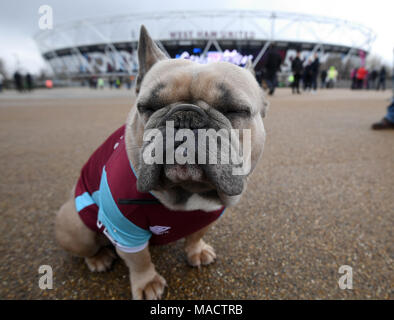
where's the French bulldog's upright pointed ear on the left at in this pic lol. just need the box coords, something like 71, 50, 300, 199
135, 25, 168, 93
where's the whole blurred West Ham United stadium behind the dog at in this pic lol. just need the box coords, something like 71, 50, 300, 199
35, 11, 376, 78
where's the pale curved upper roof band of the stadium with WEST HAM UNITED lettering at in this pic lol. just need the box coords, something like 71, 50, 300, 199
35, 10, 376, 52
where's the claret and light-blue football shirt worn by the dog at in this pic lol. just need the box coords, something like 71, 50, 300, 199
75, 126, 224, 252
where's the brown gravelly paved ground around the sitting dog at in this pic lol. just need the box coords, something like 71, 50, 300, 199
0, 89, 394, 299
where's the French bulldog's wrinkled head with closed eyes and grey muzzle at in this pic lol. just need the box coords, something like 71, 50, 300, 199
126, 26, 266, 207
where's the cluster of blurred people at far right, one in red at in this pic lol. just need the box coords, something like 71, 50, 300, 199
350, 66, 387, 91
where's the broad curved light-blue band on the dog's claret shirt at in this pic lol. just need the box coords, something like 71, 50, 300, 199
98, 167, 152, 247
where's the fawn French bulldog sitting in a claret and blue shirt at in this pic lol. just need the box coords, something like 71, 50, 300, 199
55, 26, 267, 299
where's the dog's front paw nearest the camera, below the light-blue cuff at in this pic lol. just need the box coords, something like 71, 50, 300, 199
131, 271, 167, 300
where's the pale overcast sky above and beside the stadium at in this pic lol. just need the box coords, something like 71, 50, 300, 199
0, 0, 394, 73
